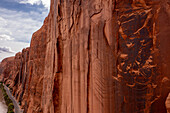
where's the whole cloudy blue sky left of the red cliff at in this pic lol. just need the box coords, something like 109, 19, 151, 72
0, 0, 50, 62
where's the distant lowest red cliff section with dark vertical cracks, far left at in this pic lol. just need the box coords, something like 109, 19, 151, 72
0, 48, 29, 106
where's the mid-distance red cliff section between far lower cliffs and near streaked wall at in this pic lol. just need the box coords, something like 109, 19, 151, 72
22, 18, 49, 113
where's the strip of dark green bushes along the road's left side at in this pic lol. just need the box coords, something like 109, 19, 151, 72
0, 83, 14, 113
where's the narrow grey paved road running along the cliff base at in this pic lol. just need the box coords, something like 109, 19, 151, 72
4, 85, 23, 113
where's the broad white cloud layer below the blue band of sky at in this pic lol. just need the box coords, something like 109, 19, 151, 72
0, 7, 48, 61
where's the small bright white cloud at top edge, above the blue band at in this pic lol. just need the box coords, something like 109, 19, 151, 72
19, 0, 50, 9
